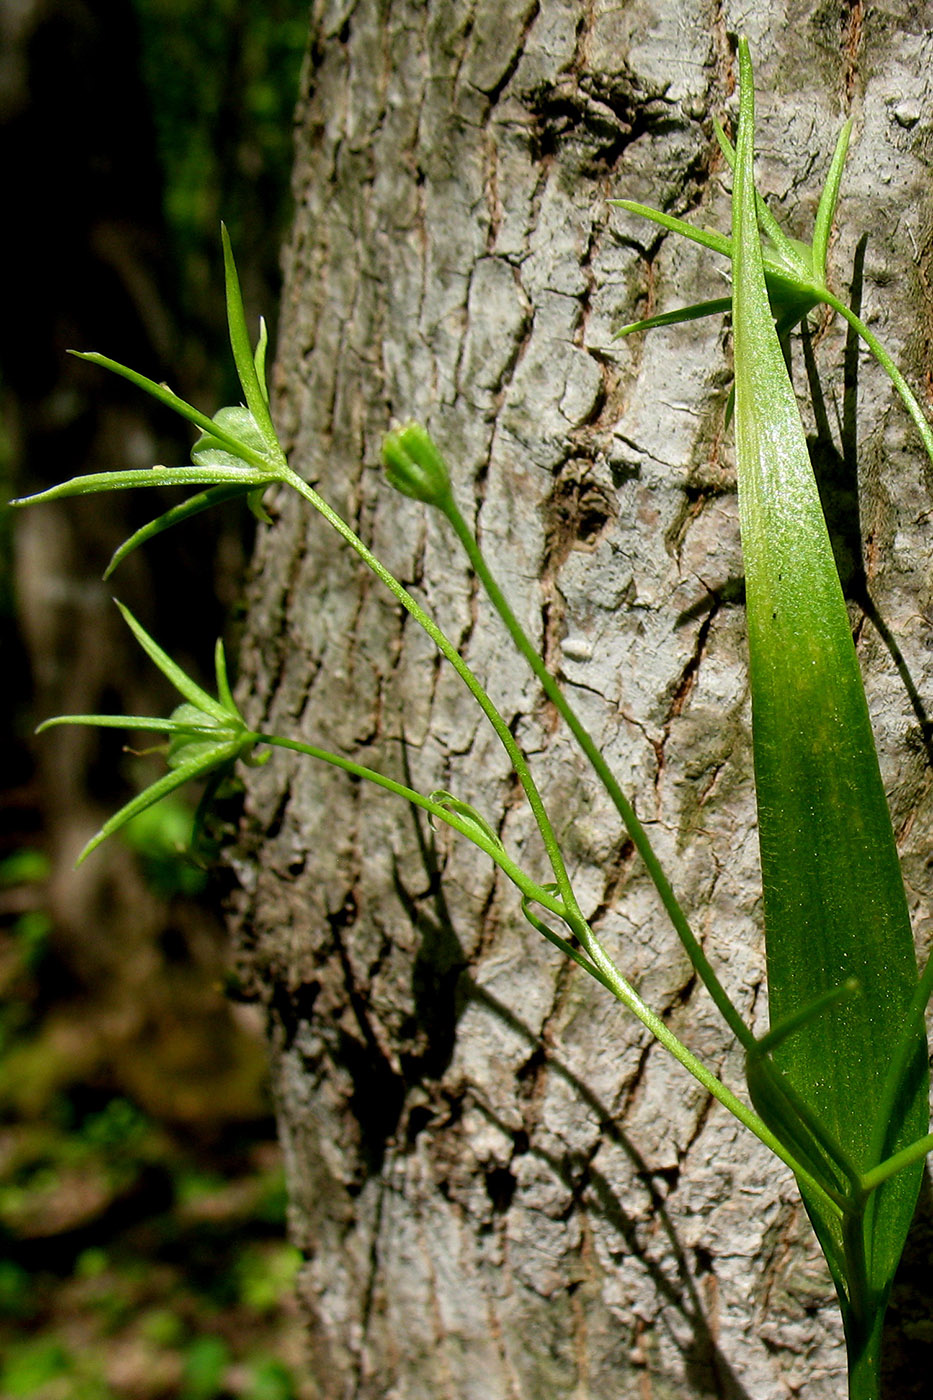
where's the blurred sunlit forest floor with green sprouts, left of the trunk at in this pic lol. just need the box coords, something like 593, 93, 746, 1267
0, 828, 311, 1400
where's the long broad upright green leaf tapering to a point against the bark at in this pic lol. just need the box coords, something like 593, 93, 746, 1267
733, 42, 927, 1336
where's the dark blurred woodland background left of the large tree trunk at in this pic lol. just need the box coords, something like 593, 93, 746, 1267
0, 0, 310, 1400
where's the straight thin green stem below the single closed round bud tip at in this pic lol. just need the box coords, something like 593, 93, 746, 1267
441, 496, 755, 1050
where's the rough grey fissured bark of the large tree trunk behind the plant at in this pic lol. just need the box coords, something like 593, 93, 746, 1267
240, 0, 933, 1400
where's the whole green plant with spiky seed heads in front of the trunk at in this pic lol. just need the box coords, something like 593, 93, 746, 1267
12, 43, 933, 1400
